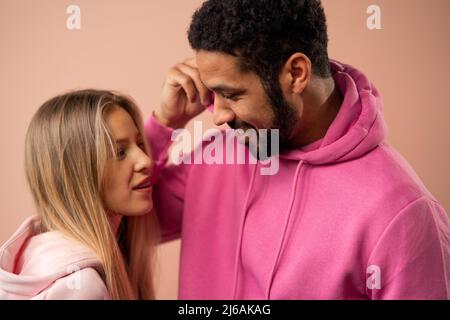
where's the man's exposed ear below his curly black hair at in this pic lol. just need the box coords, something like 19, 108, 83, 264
280, 52, 312, 94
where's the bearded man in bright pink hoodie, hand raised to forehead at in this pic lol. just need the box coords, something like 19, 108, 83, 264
146, 0, 450, 299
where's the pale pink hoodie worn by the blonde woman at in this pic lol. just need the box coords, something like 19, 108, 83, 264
0, 217, 109, 300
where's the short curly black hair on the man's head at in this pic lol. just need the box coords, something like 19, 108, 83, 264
188, 0, 330, 79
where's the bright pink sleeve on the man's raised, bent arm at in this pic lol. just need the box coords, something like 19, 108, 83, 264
145, 115, 188, 242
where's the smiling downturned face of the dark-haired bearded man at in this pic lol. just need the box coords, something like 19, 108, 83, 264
196, 51, 291, 152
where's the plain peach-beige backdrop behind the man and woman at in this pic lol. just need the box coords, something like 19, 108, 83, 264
0, 0, 450, 299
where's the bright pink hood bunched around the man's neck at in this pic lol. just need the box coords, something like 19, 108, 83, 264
280, 60, 387, 165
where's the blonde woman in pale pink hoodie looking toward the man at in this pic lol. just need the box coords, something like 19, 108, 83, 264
0, 90, 159, 299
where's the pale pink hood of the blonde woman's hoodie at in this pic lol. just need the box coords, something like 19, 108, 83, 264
0, 216, 101, 299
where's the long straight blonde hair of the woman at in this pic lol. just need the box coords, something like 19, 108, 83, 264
25, 90, 159, 299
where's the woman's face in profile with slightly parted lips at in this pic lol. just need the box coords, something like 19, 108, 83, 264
103, 106, 153, 216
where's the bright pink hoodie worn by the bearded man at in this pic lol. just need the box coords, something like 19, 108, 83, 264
145, 61, 450, 299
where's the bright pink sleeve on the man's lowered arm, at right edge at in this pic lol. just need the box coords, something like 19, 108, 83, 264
366, 197, 450, 300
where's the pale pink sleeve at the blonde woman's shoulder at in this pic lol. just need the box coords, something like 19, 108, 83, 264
39, 268, 109, 300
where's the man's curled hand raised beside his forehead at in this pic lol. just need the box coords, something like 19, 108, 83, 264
155, 58, 210, 129
